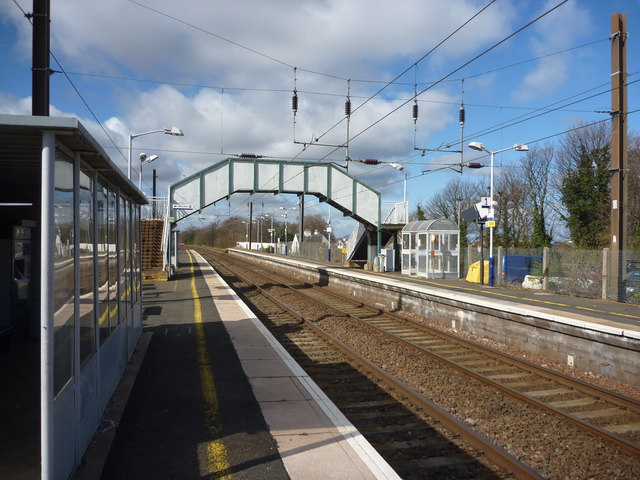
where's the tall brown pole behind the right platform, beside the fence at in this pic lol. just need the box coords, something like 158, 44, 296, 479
609, 13, 628, 301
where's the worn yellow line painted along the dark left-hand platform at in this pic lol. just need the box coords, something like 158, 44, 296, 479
186, 251, 231, 479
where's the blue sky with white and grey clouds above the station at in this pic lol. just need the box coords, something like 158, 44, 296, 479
0, 0, 640, 236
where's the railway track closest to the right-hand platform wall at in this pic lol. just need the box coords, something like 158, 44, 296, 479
266, 262, 640, 455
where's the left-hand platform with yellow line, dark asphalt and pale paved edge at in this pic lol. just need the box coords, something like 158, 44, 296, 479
75, 251, 399, 480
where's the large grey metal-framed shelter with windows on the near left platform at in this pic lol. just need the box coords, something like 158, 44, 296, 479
0, 115, 147, 480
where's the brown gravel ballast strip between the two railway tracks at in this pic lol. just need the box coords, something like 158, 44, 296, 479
319, 318, 640, 479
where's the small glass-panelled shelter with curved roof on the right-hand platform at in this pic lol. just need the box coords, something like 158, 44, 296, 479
401, 219, 460, 278
